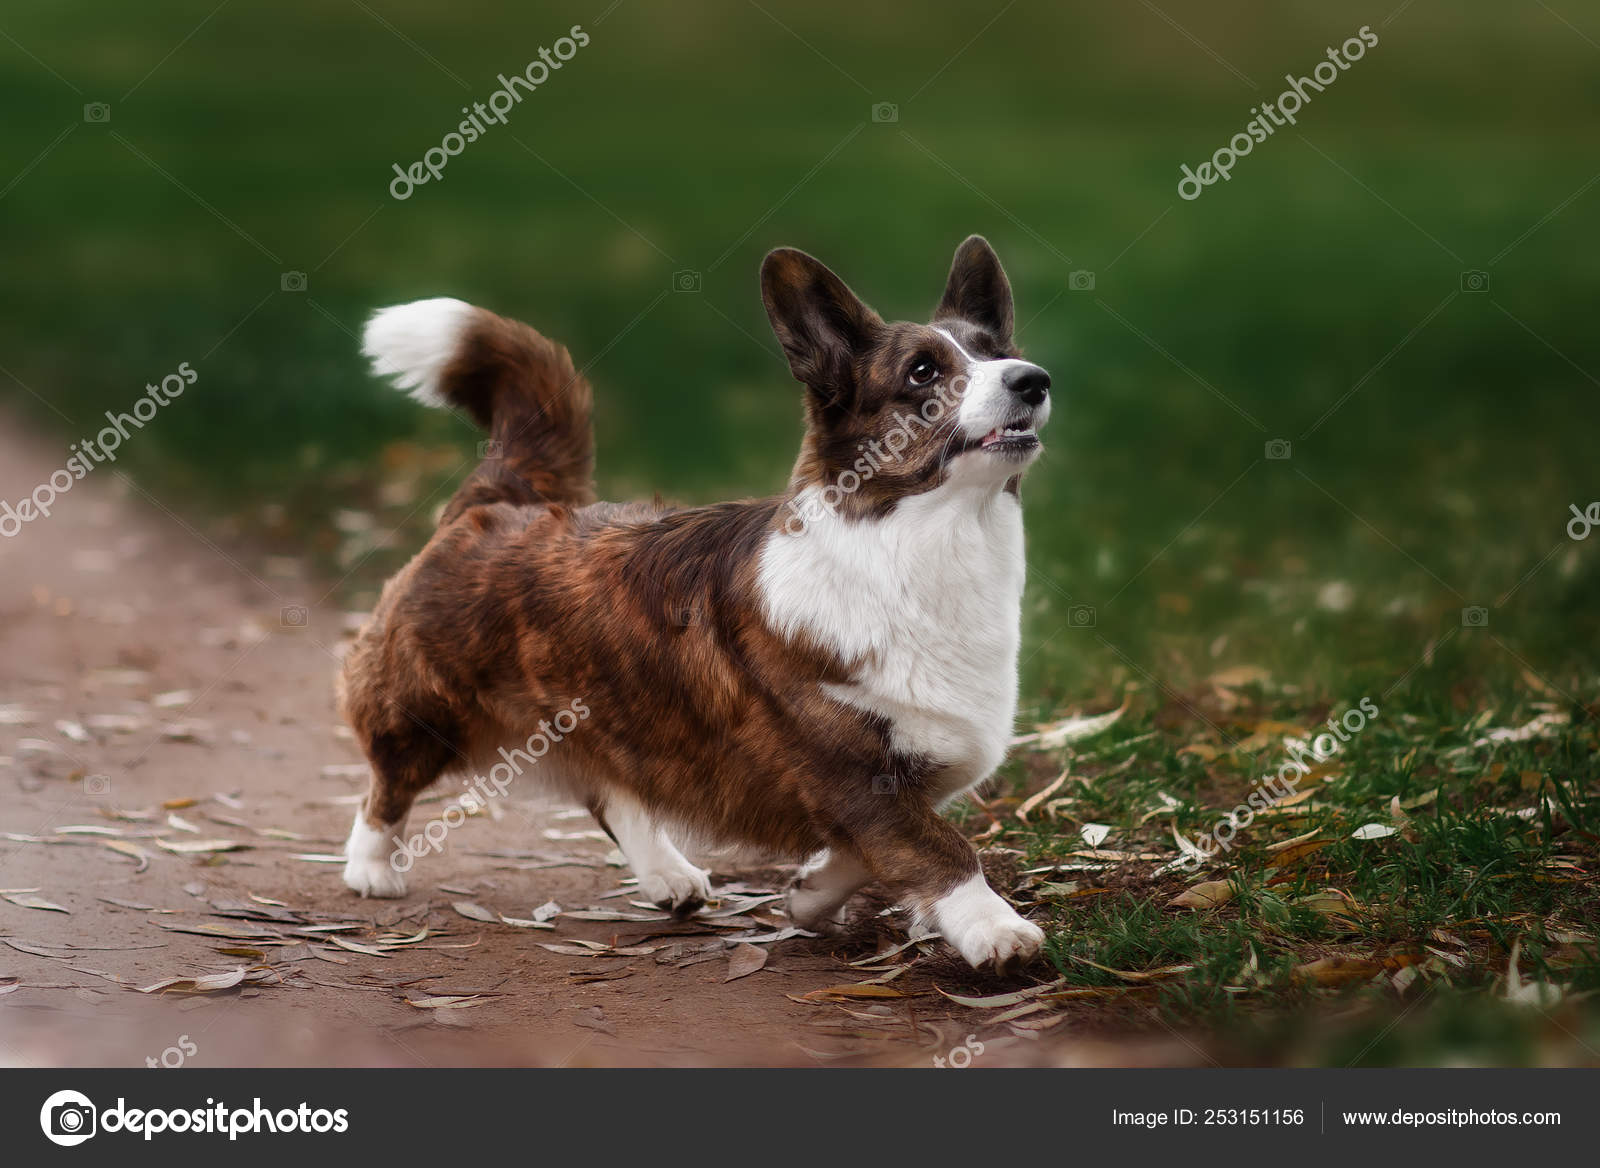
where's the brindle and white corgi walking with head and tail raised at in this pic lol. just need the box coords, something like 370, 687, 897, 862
339, 235, 1051, 968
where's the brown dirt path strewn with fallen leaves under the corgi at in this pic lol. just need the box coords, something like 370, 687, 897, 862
0, 426, 1171, 1066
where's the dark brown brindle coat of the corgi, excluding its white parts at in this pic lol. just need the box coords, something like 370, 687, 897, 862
342, 237, 1036, 909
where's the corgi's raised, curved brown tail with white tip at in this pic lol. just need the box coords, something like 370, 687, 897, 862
362, 298, 594, 520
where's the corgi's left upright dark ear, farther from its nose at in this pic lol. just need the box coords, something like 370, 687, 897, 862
762, 248, 883, 405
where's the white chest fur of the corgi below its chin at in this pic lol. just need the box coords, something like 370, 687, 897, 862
760, 483, 1026, 798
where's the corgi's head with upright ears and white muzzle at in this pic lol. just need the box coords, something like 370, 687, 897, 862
762, 235, 1050, 515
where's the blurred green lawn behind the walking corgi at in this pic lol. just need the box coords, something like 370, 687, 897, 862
0, 0, 1600, 717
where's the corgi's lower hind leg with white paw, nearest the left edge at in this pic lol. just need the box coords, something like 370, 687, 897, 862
344, 725, 456, 896
